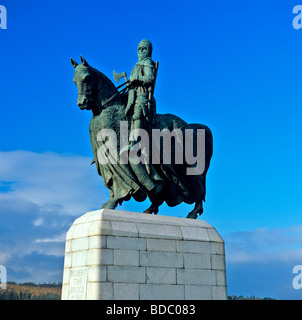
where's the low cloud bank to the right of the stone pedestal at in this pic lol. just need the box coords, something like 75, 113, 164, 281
223, 225, 302, 299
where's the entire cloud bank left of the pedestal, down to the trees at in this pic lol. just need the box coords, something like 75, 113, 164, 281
0, 151, 108, 282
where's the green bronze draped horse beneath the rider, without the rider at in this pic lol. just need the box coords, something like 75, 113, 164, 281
71, 56, 213, 219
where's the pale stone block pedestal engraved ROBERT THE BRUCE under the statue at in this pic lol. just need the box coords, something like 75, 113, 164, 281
62, 209, 227, 300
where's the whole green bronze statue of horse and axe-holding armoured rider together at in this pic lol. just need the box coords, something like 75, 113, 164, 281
71, 39, 213, 219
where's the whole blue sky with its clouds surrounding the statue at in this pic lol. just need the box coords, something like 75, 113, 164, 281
0, 0, 302, 299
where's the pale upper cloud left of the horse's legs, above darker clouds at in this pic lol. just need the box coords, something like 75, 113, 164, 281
0, 151, 107, 216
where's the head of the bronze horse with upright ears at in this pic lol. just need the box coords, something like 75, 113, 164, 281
71, 56, 117, 113
